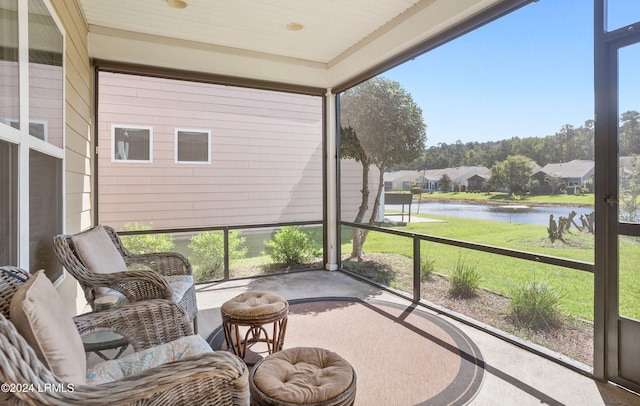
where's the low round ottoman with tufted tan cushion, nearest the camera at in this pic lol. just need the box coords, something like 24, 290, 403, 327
249, 347, 356, 406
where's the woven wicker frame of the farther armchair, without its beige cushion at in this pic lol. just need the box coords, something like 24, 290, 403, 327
53, 225, 198, 332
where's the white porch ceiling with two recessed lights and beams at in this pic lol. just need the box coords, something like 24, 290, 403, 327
78, 0, 498, 87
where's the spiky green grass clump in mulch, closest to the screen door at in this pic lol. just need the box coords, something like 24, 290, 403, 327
509, 280, 562, 329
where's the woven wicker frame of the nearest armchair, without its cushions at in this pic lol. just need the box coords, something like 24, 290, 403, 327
0, 267, 249, 405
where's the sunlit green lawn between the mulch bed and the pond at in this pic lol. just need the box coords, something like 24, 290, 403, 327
342, 216, 640, 320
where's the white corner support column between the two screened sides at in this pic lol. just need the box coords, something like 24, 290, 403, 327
325, 89, 338, 271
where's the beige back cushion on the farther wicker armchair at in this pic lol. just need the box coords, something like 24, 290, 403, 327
71, 226, 127, 273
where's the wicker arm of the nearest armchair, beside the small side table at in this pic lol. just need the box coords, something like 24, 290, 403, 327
73, 299, 193, 352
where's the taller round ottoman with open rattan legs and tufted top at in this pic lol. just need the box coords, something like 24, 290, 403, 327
220, 291, 289, 361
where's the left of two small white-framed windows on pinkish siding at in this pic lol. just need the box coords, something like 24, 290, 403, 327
111, 126, 153, 162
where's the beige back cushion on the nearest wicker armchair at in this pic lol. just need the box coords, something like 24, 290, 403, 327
9, 271, 87, 384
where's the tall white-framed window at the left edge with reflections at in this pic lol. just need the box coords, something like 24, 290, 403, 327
0, 0, 65, 283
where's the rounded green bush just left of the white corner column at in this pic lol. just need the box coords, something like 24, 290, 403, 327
266, 226, 322, 266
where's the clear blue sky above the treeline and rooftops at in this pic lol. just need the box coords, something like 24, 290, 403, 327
381, 0, 640, 147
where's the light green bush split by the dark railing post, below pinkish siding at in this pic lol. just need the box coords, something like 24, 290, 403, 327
188, 231, 248, 282
